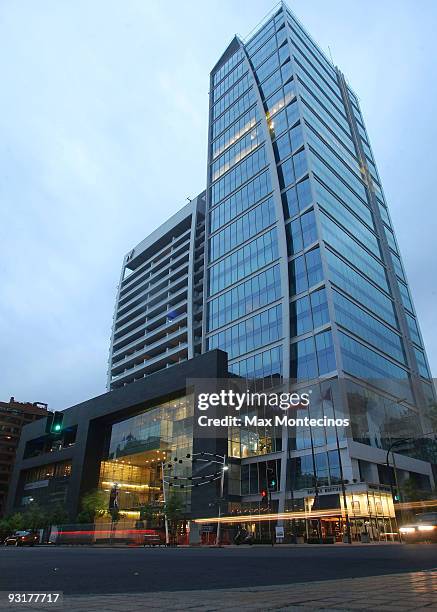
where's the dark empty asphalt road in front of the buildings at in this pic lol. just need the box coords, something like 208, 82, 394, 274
0, 544, 437, 595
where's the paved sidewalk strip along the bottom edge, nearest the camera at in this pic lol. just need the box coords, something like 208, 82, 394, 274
5, 568, 437, 612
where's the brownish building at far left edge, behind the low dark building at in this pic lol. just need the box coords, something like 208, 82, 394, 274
0, 397, 47, 517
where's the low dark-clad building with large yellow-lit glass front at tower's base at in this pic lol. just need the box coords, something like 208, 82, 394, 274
7, 351, 227, 521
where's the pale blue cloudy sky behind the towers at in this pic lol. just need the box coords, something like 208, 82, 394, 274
0, 0, 437, 410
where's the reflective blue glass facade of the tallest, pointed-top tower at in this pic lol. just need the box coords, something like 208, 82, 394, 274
204, 5, 436, 404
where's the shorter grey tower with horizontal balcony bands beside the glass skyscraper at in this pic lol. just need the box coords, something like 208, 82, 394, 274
108, 192, 205, 389
